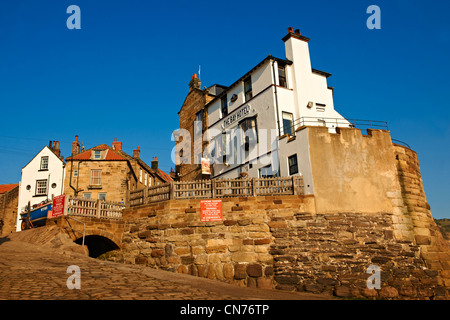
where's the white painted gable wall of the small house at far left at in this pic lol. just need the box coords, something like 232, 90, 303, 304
16, 146, 64, 231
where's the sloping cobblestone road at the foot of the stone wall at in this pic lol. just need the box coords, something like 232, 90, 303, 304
0, 238, 329, 300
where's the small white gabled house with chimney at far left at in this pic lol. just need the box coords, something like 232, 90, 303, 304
16, 141, 64, 231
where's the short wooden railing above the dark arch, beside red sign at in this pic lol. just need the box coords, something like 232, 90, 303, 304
66, 197, 125, 219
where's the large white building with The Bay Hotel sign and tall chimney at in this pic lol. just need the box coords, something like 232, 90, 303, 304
200, 28, 351, 185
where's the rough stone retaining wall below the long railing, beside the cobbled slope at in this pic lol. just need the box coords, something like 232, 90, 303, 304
112, 196, 448, 299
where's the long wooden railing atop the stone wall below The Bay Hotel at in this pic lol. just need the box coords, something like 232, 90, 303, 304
128, 176, 304, 207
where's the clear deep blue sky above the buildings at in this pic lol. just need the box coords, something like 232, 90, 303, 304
0, 0, 450, 218
